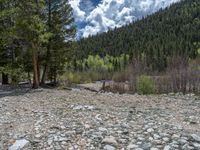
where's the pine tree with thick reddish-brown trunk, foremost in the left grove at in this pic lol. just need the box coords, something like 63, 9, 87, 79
15, 0, 49, 88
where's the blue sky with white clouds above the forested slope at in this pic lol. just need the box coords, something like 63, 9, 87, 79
69, 0, 179, 37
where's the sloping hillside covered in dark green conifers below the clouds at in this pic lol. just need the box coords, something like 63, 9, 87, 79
76, 0, 200, 70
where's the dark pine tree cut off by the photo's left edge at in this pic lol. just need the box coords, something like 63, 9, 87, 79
0, 0, 16, 84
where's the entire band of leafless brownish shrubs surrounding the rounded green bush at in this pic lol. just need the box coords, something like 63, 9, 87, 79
109, 56, 200, 94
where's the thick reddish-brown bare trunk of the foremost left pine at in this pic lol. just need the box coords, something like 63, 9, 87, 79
32, 43, 39, 89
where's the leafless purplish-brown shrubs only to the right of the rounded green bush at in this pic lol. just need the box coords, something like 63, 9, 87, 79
154, 57, 200, 93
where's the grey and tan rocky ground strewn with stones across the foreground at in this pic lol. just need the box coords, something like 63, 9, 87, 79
0, 85, 200, 150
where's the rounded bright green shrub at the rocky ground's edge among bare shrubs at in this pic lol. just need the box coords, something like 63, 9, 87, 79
136, 75, 156, 94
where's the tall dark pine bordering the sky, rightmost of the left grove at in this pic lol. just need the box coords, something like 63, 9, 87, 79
41, 0, 75, 84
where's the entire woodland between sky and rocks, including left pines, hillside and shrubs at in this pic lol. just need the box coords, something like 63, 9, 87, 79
0, 0, 200, 93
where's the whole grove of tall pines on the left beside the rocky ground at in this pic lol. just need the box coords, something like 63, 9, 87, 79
0, 0, 76, 88
